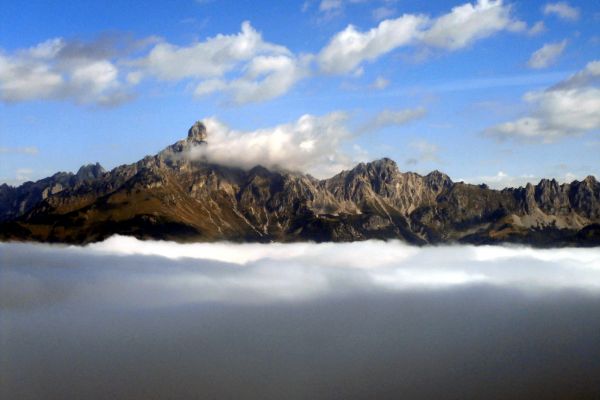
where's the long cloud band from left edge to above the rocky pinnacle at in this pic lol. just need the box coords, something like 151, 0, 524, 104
0, 22, 300, 105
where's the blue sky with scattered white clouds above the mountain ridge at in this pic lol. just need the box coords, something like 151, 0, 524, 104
0, 0, 600, 188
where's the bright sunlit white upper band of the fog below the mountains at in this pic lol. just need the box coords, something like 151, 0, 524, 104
52, 236, 600, 296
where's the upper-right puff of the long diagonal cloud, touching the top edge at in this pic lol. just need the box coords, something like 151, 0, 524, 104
423, 0, 525, 50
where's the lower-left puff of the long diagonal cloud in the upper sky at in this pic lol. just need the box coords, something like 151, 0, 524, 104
318, 14, 427, 74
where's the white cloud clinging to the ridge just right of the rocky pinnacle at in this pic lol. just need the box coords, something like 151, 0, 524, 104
189, 112, 354, 177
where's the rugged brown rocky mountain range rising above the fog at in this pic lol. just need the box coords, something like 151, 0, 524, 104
0, 123, 600, 246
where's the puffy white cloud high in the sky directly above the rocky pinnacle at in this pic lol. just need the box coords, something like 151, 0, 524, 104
133, 21, 310, 104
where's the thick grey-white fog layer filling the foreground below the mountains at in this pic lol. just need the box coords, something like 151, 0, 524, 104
0, 237, 600, 399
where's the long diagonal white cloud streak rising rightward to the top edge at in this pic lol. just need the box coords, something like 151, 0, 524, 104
317, 0, 526, 74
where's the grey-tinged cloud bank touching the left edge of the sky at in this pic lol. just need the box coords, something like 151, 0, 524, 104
0, 38, 136, 106
